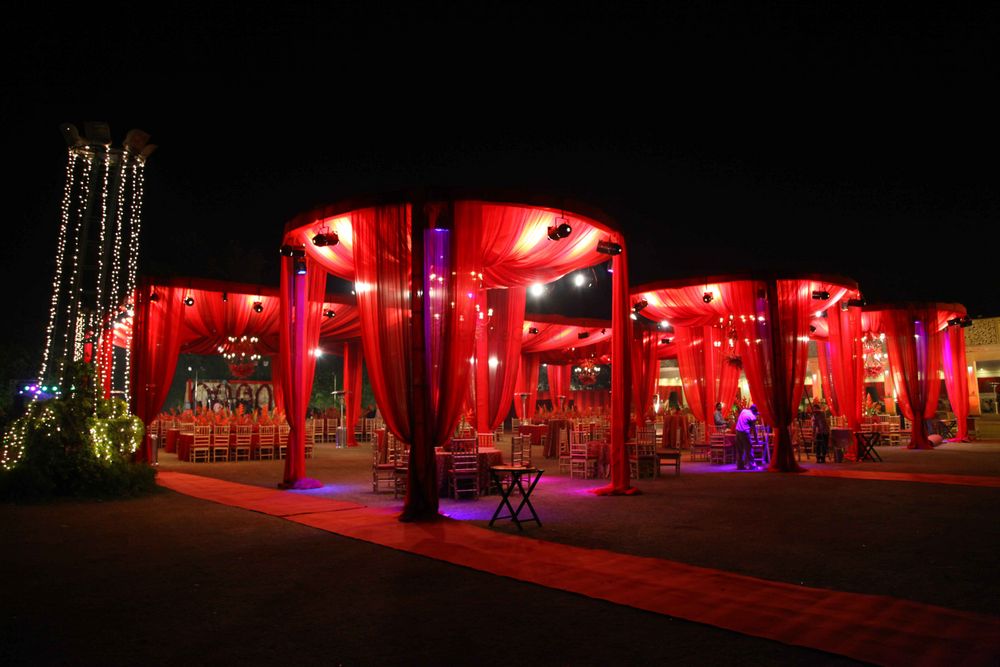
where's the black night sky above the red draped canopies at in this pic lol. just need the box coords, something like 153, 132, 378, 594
0, 2, 1000, 374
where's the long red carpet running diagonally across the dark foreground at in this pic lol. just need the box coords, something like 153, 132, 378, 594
157, 471, 1000, 666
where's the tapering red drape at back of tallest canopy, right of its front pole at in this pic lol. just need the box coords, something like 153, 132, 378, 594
476, 287, 526, 433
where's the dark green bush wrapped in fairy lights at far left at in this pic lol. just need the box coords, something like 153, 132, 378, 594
0, 365, 156, 500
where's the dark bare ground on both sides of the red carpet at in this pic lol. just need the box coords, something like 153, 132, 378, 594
0, 442, 1000, 665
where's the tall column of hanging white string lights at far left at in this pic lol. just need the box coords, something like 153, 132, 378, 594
30, 123, 155, 408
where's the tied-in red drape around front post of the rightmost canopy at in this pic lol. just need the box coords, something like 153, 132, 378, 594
881, 306, 941, 449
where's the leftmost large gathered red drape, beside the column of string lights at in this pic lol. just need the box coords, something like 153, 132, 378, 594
131, 283, 184, 463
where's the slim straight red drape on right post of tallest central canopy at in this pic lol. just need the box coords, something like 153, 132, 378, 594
594, 239, 637, 495
